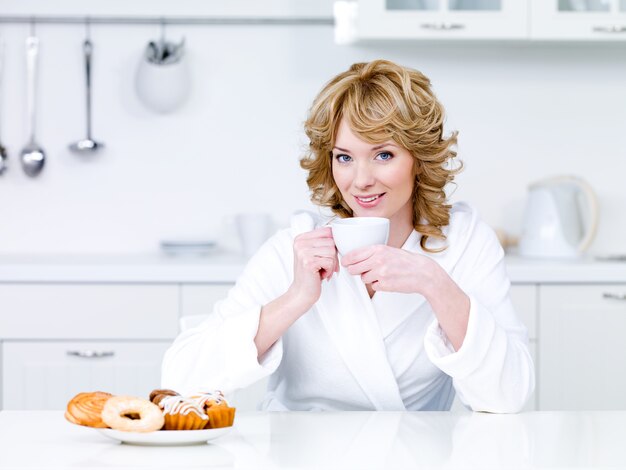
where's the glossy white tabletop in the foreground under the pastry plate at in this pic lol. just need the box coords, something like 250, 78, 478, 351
0, 411, 626, 470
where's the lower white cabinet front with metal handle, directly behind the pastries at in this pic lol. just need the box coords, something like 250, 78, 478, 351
2, 341, 170, 410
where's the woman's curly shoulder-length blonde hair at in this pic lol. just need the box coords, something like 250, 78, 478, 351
300, 60, 463, 252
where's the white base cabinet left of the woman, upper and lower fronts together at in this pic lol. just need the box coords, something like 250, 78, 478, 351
0, 283, 179, 409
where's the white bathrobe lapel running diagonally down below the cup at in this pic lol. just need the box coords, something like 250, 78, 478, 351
316, 269, 405, 410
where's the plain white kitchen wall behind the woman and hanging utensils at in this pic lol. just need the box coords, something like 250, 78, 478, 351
0, 4, 626, 253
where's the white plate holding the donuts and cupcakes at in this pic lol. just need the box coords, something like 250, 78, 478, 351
94, 426, 232, 446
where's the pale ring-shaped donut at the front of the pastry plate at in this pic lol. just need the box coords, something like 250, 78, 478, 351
102, 395, 164, 432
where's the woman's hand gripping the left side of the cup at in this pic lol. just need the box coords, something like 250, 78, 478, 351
289, 227, 339, 311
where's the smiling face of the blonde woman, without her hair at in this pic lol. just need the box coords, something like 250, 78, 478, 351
332, 120, 415, 225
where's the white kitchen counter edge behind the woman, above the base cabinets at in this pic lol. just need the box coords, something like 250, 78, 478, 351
0, 251, 626, 284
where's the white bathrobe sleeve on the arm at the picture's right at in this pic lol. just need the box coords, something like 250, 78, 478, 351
424, 210, 535, 413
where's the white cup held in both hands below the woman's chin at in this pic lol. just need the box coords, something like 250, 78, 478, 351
330, 217, 389, 256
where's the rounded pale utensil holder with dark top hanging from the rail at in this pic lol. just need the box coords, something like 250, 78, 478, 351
135, 24, 190, 113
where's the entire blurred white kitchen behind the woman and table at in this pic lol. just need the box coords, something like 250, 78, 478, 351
0, 0, 626, 410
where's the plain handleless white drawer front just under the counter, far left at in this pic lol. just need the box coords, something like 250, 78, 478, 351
0, 284, 178, 339
